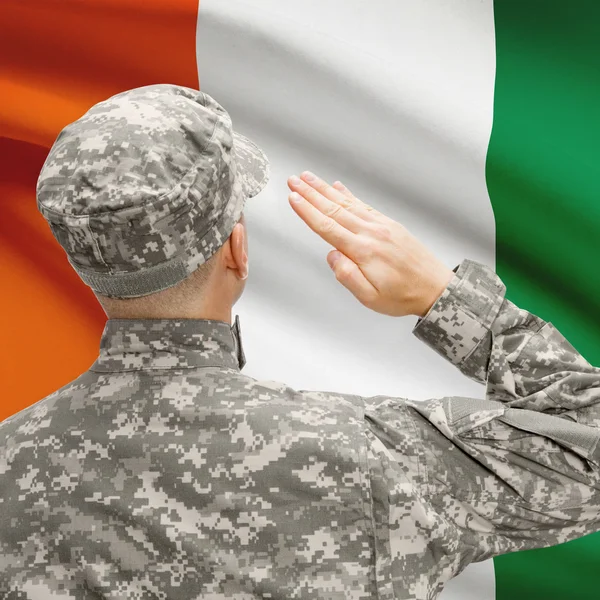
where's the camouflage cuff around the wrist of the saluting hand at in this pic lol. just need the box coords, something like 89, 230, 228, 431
413, 259, 506, 366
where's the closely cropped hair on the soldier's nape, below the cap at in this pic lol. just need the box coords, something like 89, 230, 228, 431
94, 251, 219, 319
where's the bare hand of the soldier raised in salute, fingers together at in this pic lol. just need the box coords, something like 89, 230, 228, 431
288, 171, 454, 317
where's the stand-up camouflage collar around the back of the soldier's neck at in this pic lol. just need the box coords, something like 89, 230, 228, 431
90, 315, 246, 373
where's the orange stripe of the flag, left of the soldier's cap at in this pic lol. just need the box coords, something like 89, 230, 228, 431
0, 0, 198, 420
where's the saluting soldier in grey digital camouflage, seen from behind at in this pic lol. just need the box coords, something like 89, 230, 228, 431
0, 85, 600, 600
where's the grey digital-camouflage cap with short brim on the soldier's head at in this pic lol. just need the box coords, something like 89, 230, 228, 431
37, 84, 269, 298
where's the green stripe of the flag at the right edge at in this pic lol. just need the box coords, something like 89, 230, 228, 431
486, 0, 600, 600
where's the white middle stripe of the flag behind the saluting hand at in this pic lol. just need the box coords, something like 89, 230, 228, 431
197, 0, 495, 600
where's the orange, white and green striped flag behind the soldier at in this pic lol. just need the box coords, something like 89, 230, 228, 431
0, 0, 600, 600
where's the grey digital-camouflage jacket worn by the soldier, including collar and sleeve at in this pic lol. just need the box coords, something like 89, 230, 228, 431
0, 260, 600, 600
